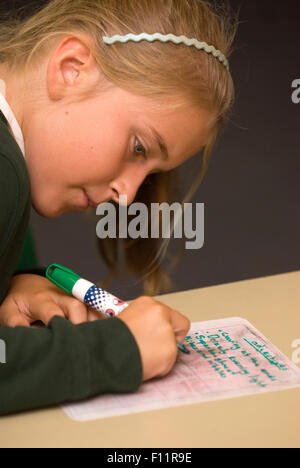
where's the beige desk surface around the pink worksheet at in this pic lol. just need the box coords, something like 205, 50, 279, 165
0, 272, 300, 448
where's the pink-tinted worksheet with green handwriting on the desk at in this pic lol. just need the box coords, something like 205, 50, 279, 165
63, 318, 300, 421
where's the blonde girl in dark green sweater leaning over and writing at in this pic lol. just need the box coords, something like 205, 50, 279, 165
0, 0, 236, 414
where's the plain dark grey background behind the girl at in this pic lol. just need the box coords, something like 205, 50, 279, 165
0, 0, 300, 299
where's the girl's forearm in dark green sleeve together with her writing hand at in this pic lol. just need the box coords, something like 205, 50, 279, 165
0, 297, 190, 415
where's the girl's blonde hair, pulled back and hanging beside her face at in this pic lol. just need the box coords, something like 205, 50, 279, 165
0, 0, 238, 295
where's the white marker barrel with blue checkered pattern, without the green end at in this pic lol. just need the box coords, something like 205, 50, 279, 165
72, 279, 128, 317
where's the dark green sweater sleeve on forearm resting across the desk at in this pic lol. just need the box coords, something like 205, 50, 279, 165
0, 316, 142, 415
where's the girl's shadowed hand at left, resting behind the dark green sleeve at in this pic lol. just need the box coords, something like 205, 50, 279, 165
0, 275, 102, 327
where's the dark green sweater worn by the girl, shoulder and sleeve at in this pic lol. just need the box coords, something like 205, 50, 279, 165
0, 112, 142, 415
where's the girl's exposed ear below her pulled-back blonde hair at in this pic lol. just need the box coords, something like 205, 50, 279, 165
47, 35, 99, 101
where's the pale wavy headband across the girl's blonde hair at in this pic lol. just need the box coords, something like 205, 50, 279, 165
103, 33, 229, 71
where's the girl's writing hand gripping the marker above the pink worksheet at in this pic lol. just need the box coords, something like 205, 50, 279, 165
118, 296, 190, 380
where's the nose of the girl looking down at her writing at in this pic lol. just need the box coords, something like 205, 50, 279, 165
110, 170, 147, 205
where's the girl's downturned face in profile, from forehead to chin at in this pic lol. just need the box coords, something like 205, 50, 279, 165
23, 87, 211, 218
